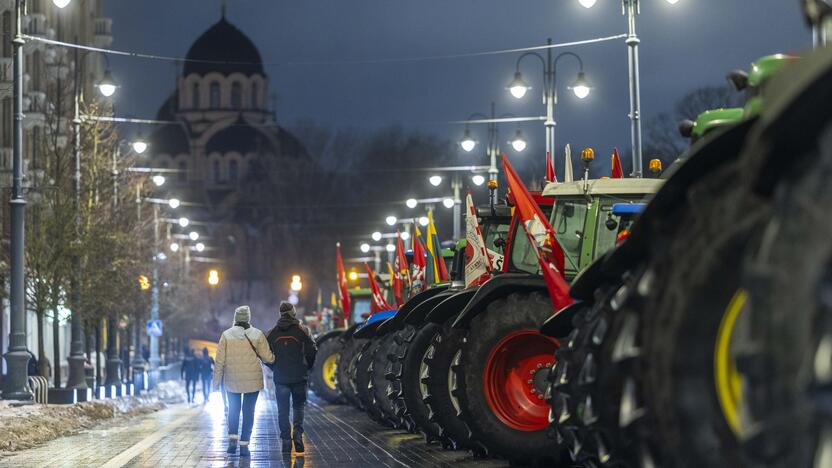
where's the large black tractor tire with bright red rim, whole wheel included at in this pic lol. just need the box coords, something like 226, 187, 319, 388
453, 292, 561, 463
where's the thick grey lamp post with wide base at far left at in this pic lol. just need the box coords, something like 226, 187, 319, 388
3, 0, 32, 400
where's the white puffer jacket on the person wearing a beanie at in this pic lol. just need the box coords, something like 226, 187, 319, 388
214, 325, 274, 393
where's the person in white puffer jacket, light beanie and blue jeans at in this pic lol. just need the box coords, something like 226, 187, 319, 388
213, 306, 274, 457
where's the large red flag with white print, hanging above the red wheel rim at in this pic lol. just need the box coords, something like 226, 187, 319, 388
503, 153, 572, 311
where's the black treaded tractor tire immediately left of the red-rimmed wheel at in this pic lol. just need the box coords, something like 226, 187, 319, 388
420, 324, 482, 455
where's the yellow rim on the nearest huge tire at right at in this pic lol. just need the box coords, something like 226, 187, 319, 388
714, 289, 748, 434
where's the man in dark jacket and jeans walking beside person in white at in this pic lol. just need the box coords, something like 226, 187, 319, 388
266, 302, 317, 454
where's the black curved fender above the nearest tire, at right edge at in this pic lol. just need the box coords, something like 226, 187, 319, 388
743, 47, 832, 196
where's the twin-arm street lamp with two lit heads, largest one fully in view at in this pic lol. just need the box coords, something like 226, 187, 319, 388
508, 38, 590, 172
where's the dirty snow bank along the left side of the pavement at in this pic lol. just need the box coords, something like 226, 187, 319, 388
0, 382, 184, 455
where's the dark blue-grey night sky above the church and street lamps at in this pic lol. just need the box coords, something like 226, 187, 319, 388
106, 0, 810, 168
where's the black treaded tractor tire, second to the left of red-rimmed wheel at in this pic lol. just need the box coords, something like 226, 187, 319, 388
387, 323, 441, 443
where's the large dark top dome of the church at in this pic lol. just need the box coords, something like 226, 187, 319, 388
182, 16, 265, 76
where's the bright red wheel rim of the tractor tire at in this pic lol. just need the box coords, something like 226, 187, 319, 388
484, 330, 558, 432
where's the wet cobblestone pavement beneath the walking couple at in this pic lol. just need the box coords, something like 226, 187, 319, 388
0, 392, 505, 468
